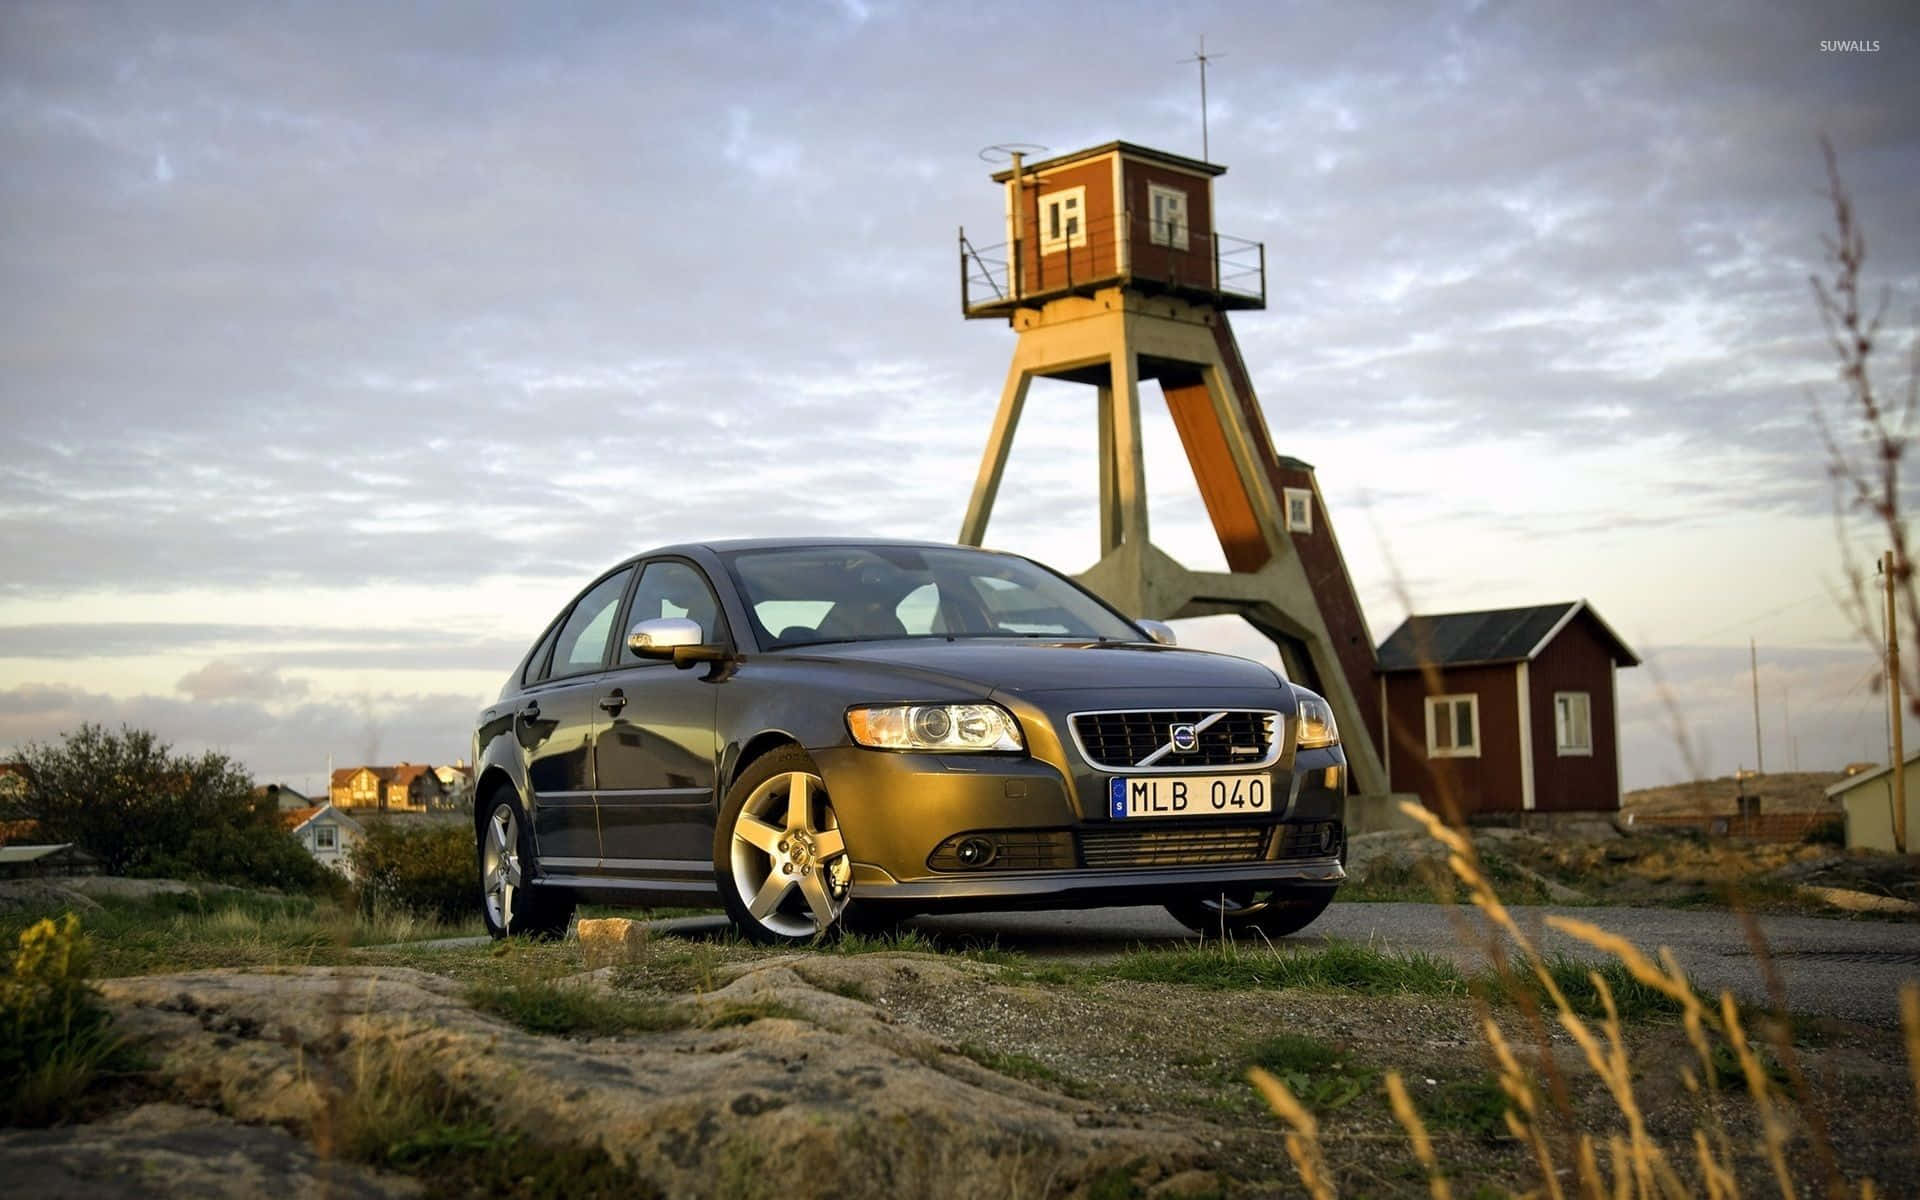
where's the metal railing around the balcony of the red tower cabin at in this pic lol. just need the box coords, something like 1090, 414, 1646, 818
960, 211, 1267, 317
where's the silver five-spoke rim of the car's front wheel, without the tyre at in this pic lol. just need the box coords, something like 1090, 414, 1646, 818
730, 770, 852, 937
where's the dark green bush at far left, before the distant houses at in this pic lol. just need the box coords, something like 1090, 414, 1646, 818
0, 724, 334, 891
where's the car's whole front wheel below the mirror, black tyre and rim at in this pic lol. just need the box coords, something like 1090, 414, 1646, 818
714, 747, 852, 945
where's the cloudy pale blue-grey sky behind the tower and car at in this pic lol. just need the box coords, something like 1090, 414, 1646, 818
0, 0, 1920, 789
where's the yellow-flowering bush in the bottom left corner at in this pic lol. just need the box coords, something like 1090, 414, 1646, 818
0, 912, 121, 1125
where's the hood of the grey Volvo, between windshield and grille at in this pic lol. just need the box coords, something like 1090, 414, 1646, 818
768, 637, 1281, 695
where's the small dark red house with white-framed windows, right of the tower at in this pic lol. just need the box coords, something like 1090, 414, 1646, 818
1379, 601, 1640, 816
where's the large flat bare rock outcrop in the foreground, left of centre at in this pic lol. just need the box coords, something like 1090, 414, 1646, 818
102, 954, 1206, 1198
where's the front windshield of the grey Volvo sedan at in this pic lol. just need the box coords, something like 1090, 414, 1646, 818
726, 545, 1140, 649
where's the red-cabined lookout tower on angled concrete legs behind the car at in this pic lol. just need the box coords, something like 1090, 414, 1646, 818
960, 142, 1386, 793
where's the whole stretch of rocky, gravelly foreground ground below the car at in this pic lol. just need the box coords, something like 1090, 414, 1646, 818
0, 913, 1920, 1198
